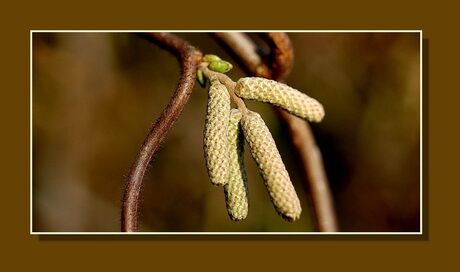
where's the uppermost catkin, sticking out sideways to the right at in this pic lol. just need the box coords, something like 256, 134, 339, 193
235, 77, 324, 122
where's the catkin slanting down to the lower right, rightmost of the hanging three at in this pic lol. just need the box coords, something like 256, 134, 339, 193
241, 111, 302, 221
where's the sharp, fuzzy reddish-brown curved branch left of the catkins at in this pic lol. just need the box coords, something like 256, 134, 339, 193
121, 33, 202, 232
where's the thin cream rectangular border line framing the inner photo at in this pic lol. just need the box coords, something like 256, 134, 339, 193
29, 29, 424, 236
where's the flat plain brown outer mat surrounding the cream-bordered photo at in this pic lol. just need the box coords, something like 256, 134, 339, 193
0, 1, 459, 271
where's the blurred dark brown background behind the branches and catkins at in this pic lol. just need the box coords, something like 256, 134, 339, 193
32, 33, 420, 232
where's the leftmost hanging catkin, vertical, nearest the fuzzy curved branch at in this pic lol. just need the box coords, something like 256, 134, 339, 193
204, 79, 230, 185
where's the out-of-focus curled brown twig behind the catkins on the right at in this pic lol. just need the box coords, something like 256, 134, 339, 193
216, 32, 337, 232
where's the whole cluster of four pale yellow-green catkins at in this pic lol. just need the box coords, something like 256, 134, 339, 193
204, 66, 324, 221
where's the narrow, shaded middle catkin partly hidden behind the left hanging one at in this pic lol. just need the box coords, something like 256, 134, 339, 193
224, 109, 249, 221
